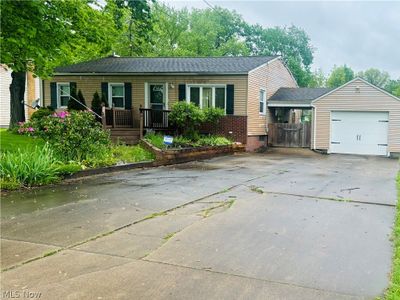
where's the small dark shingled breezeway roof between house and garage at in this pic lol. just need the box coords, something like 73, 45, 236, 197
268, 88, 333, 106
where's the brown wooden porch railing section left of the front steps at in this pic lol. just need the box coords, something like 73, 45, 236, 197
101, 106, 134, 128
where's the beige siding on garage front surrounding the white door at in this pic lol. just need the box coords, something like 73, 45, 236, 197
311, 80, 400, 152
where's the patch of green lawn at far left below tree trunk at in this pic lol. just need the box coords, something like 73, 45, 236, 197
0, 129, 44, 152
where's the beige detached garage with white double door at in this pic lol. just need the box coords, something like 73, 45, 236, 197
311, 78, 400, 156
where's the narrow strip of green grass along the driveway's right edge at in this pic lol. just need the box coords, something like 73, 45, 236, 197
385, 172, 400, 300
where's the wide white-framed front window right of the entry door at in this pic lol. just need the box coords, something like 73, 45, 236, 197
187, 85, 226, 110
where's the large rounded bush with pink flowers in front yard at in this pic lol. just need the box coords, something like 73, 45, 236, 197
18, 111, 111, 166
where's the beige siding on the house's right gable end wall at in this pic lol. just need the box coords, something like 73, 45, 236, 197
247, 59, 297, 135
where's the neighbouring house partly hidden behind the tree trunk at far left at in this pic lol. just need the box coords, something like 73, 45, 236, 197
0, 65, 40, 128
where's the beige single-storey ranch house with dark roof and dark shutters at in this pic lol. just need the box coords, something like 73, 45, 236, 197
43, 56, 297, 150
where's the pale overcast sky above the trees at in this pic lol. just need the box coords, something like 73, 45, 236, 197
163, 0, 400, 78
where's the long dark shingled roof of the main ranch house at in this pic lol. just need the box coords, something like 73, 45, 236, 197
55, 56, 277, 74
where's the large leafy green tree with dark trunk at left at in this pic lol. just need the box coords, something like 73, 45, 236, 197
0, 0, 115, 127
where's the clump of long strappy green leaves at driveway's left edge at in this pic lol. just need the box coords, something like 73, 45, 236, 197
0, 144, 60, 188
